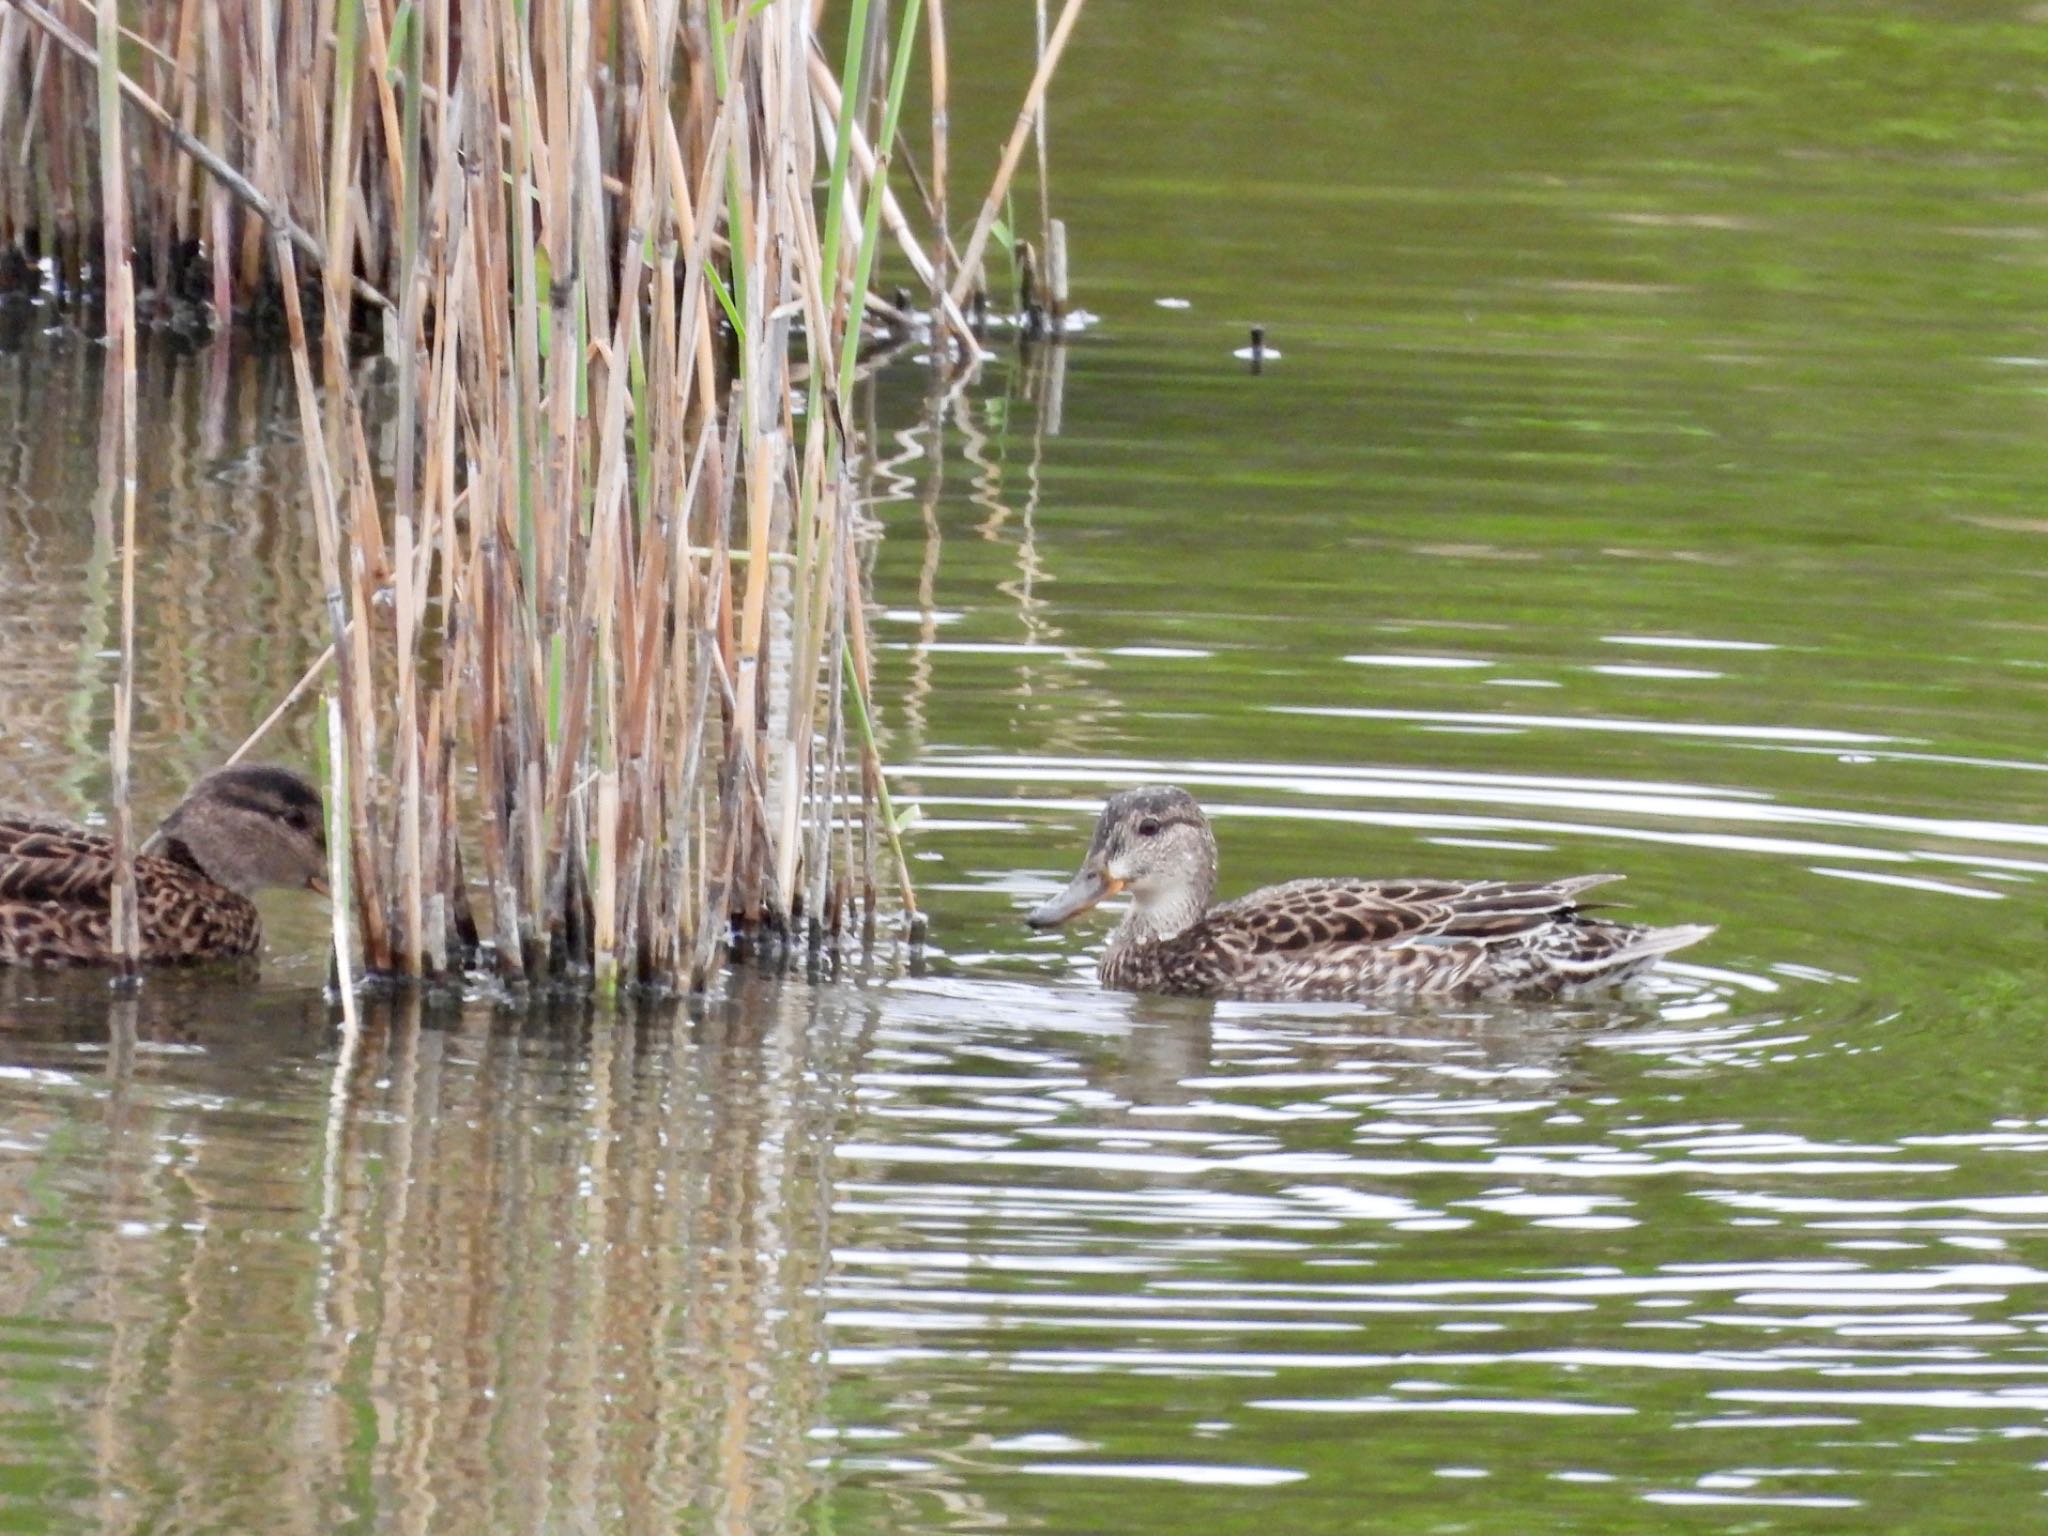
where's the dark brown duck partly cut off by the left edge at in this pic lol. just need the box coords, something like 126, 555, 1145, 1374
0, 766, 328, 967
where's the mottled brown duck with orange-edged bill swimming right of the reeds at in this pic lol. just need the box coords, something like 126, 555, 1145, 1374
1026, 784, 1714, 1004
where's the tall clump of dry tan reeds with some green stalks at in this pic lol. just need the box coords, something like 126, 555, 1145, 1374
0, 0, 1081, 989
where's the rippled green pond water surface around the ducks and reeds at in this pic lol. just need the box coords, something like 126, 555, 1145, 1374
0, 0, 2048, 1536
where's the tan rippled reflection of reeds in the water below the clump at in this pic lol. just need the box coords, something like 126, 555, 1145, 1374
0, 977, 866, 1532
